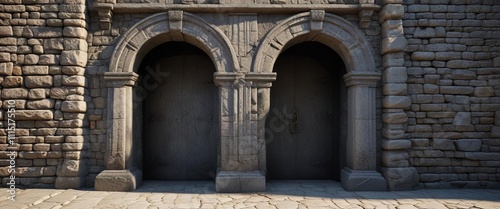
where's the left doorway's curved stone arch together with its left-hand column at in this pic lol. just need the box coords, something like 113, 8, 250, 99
95, 10, 239, 191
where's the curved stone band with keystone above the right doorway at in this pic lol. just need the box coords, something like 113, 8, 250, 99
252, 10, 376, 73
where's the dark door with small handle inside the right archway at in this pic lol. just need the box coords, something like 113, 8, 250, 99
266, 53, 340, 179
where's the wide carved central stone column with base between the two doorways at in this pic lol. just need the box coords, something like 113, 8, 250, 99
214, 73, 276, 192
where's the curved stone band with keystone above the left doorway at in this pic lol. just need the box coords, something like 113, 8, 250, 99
109, 11, 239, 72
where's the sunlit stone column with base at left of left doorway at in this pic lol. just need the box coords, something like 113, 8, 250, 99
95, 72, 142, 191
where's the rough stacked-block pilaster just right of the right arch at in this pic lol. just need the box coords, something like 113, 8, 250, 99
379, 0, 418, 190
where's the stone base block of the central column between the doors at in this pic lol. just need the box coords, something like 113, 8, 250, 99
215, 171, 266, 193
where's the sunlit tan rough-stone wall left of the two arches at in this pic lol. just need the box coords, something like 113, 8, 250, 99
0, 0, 89, 188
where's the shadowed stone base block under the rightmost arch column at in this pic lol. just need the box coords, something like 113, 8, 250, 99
341, 168, 387, 191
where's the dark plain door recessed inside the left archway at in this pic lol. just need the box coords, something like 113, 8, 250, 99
143, 50, 217, 180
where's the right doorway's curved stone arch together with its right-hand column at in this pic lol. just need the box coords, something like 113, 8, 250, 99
252, 10, 387, 190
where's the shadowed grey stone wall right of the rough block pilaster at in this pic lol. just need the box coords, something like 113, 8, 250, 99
403, 0, 500, 188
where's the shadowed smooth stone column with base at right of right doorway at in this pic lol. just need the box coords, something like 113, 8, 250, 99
341, 72, 387, 191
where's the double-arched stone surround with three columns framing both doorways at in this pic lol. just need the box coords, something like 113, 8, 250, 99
95, 10, 387, 192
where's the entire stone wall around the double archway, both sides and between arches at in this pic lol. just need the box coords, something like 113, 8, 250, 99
0, 0, 500, 190
